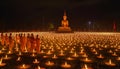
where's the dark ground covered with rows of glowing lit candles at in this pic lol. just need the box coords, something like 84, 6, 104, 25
0, 32, 120, 69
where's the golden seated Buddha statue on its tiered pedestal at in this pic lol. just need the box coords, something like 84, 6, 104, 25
57, 11, 72, 33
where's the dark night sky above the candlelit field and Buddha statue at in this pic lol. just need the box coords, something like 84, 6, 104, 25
0, 0, 120, 31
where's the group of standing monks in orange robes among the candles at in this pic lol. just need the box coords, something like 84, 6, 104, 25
0, 33, 40, 52
